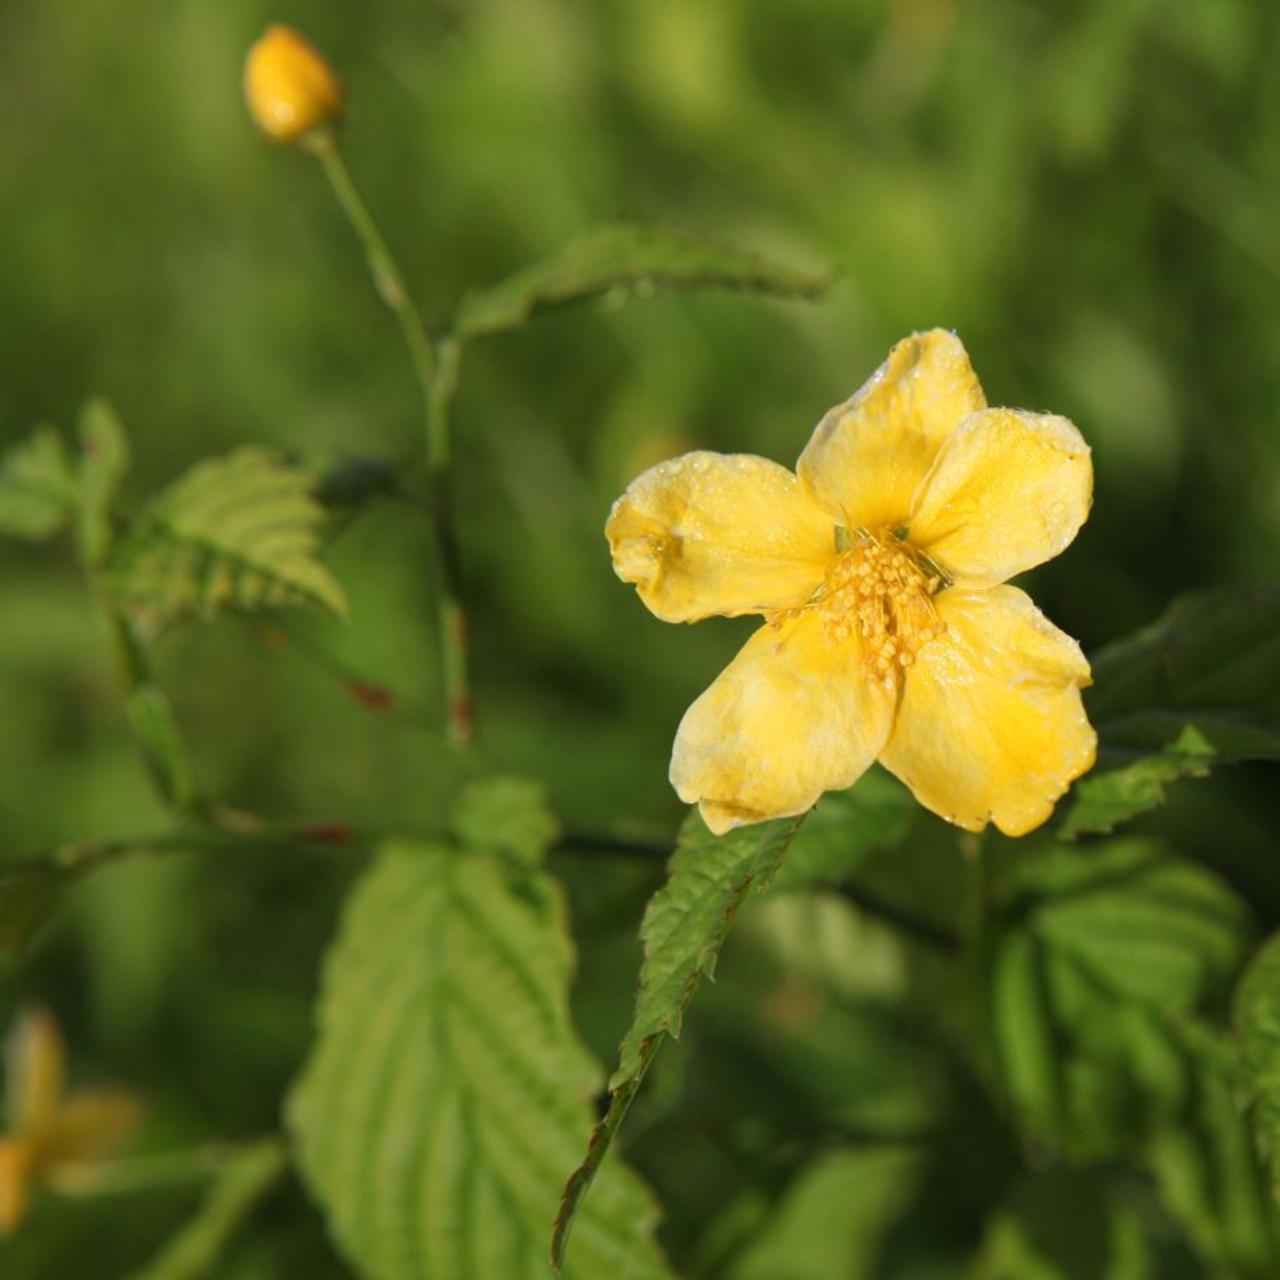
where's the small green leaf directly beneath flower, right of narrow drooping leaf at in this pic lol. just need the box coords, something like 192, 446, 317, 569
774, 769, 919, 890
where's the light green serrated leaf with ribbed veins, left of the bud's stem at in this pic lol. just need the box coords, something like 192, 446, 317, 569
106, 448, 347, 634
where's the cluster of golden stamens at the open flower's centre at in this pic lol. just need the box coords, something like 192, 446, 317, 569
810, 530, 946, 684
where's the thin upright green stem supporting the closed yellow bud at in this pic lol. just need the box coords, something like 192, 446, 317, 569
310, 131, 472, 746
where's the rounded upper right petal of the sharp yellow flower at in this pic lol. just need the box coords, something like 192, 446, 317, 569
910, 408, 1093, 586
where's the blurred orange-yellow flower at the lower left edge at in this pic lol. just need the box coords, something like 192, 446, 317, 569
0, 1011, 141, 1235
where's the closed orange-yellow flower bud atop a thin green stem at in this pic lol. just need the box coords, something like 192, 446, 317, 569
244, 24, 346, 142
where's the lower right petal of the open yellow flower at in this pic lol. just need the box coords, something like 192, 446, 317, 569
881, 586, 1097, 836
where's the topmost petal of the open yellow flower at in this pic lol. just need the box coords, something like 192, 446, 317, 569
796, 329, 987, 529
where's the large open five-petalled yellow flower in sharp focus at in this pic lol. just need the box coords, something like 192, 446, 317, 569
605, 329, 1097, 836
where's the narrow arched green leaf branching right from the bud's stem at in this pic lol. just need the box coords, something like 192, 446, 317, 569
454, 224, 827, 338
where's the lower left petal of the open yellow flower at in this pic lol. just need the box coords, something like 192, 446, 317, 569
671, 613, 896, 836
